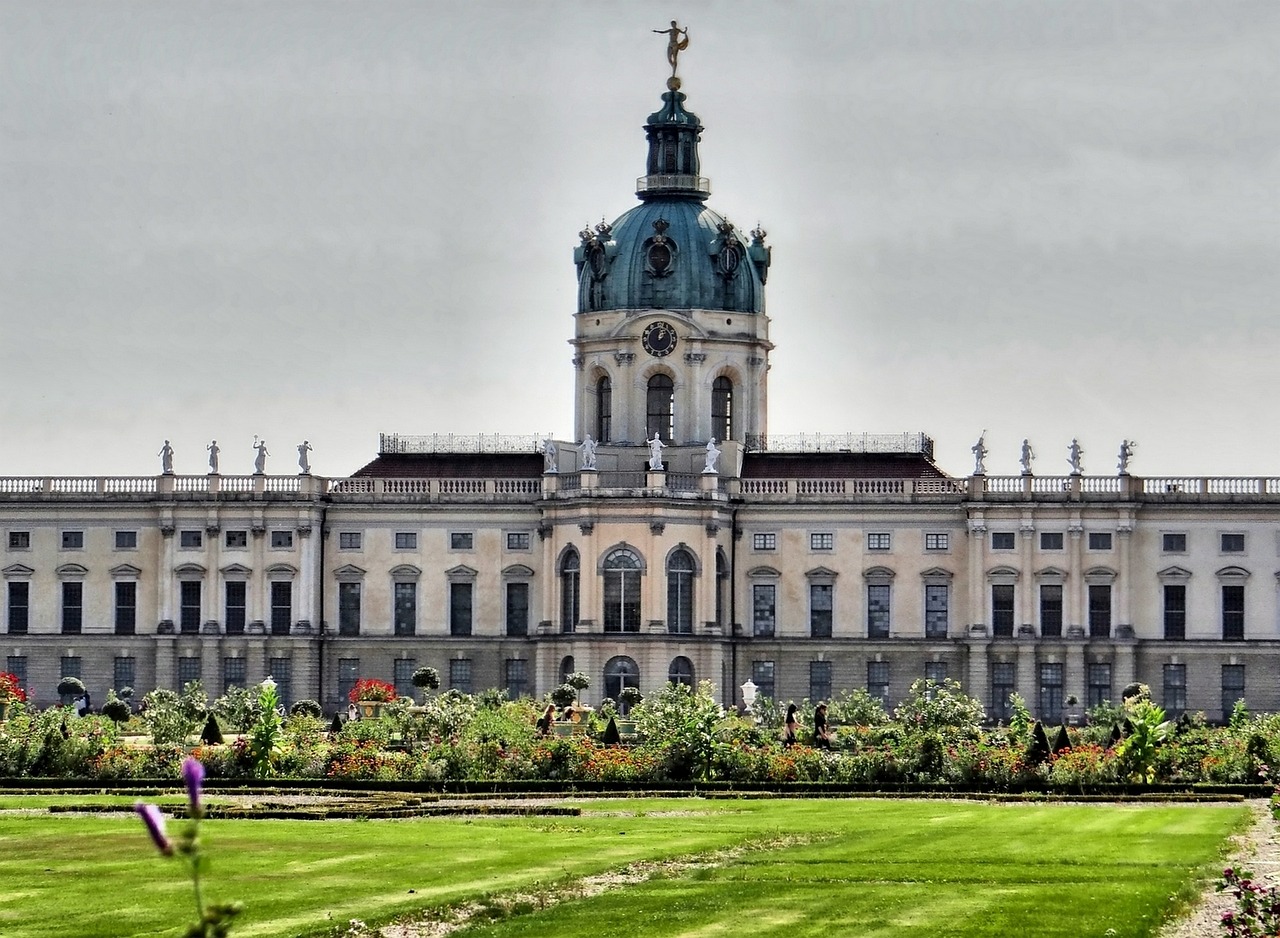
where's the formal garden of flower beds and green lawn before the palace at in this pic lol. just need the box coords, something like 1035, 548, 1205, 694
0, 669, 1280, 938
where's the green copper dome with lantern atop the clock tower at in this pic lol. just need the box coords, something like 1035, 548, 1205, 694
573, 90, 769, 312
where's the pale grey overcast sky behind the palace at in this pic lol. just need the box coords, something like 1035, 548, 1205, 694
0, 0, 1280, 476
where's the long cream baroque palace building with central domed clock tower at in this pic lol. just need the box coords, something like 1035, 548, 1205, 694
0, 65, 1280, 718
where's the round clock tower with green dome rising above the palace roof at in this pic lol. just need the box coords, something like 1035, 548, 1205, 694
572, 78, 773, 445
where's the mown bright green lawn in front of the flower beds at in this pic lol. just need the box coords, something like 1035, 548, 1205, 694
0, 799, 1248, 938
